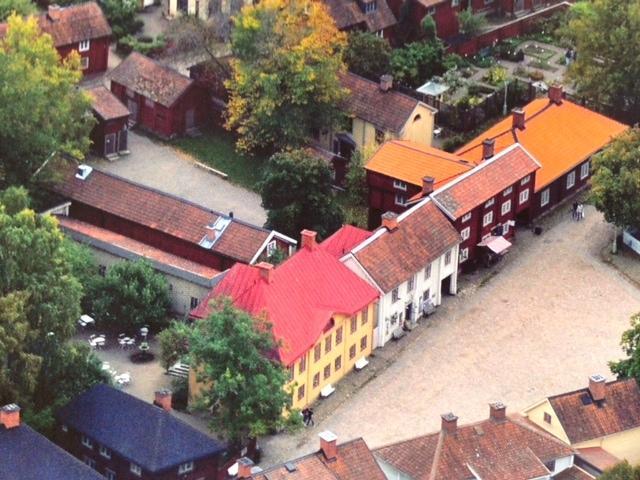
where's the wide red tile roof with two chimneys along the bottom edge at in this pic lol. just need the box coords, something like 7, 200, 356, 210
374, 417, 573, 480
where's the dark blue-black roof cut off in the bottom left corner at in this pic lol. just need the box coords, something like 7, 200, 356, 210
0, 423, 103, 480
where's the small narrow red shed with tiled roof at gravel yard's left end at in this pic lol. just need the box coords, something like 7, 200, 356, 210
87, 85, 129, 157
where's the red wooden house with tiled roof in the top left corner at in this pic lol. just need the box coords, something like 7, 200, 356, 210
0, 2, 111, 75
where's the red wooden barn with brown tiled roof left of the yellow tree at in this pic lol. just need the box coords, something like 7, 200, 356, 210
110, 52, 207, 138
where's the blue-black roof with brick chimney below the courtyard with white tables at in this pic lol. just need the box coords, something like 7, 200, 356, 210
57, 384, 225, 472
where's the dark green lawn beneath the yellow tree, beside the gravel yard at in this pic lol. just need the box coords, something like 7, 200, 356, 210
171, 129, 267, 191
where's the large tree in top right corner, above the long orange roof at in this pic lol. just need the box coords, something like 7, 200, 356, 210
568, 0, 640, 123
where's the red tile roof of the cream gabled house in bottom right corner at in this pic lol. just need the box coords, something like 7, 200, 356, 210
549, 379, 640, 444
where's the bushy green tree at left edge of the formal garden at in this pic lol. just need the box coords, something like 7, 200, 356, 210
391, 40, 444, 88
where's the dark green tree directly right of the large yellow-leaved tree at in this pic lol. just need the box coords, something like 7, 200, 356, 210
344, 31, 391, 81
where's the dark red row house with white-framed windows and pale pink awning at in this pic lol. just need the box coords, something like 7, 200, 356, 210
431, 140, 540, 267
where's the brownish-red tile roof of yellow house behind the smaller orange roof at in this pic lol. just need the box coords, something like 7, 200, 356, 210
340, 72, 428, 133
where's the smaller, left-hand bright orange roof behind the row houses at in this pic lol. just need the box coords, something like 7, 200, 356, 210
365, 140, 474, 188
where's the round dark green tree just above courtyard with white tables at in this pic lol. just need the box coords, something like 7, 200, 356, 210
89, 260, 170, 332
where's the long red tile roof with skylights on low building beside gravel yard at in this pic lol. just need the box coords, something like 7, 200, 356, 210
48, 168, 282, 263
